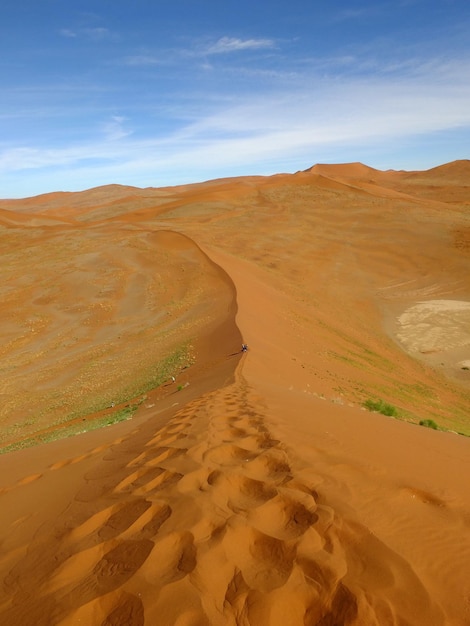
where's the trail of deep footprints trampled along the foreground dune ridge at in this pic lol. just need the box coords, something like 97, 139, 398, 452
1, 371, 441, 626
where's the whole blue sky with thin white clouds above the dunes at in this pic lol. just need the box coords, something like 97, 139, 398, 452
0, 0, 470, 198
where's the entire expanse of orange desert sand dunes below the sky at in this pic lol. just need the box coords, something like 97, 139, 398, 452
0, 161, 470, 626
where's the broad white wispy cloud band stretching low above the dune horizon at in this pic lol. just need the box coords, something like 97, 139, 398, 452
0, 60, 470, 193
